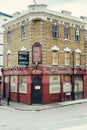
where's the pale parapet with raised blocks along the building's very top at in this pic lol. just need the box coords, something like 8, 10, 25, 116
4, 4, 87, 26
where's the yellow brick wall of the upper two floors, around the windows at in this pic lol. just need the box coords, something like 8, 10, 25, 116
4, 21, 84, 67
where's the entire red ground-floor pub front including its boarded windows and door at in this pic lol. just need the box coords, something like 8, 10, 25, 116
1, 67, 87, 104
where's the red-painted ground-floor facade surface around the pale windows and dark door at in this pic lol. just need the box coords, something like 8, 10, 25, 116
1, 67, 87, 104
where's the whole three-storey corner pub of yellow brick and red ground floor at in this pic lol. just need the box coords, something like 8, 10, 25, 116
1, 4, 87, 104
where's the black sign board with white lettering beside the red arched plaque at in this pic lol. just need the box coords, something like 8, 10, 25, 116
18, 51, 29, 65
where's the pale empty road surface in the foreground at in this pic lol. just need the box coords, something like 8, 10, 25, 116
0, 103, 87, 130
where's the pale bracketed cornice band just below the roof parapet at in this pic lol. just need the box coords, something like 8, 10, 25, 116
3, 9, 86, 31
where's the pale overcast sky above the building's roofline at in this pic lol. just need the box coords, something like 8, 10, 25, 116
0, 0, 87, 17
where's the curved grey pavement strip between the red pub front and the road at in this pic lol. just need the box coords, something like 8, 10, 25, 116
0, 99, 87, 111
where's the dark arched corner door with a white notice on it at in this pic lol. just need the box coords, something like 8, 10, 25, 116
32, 77, 42, 104
